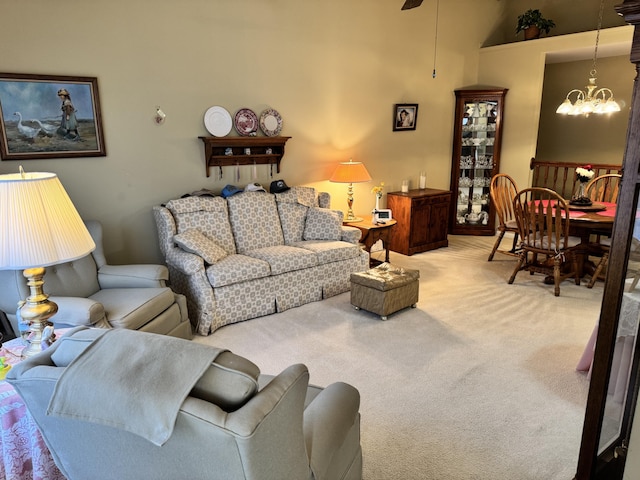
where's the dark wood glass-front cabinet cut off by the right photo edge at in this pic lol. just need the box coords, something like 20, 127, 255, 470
574, 0, 640, 480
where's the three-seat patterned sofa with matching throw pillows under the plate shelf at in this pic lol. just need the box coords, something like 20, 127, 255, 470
153, 186, 369, 335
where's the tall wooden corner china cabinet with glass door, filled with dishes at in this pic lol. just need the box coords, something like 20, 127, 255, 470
449, 86, 507, 235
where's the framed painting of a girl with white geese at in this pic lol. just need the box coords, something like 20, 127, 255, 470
0, 73, 106, 160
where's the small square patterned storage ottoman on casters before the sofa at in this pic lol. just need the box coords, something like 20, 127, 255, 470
351, 263, 420, 320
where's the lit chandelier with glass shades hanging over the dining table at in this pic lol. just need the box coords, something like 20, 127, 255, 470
556, 0, 620, 117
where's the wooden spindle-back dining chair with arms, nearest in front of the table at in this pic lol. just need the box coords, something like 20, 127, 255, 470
509, 187, 580, 297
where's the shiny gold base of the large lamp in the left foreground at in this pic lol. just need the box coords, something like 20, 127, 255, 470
19, 267, 58, 358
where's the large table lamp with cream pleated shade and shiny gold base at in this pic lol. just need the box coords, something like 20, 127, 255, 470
0, 167, 95, 357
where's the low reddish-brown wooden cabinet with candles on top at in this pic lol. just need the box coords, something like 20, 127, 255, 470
387, 188, 451, 255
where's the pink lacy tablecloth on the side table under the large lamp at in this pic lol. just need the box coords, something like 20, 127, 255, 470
0, 340, 65, 480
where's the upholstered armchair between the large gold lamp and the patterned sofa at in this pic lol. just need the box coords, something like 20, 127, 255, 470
0, 221, 192, 338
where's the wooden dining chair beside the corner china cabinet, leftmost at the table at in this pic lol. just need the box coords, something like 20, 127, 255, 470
487, 173, 519, 262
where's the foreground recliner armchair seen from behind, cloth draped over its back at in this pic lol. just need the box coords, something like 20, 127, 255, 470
7, 327, 362, 480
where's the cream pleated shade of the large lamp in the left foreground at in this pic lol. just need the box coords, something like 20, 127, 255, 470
0, 169, 96, 270
